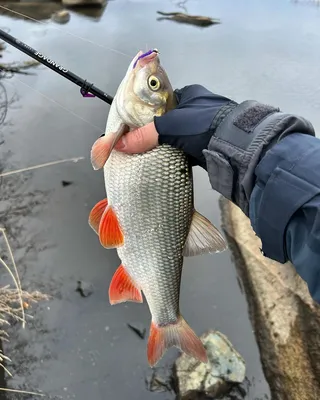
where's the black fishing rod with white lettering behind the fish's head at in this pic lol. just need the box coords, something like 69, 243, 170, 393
0, 29, 113, 104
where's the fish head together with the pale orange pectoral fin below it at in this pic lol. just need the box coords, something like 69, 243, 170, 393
91, 50, 176, 169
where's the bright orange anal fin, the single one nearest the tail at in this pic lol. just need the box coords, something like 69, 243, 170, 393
109, 264, 143, 304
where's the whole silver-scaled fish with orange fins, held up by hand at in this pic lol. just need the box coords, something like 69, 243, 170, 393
89, 49, 227, 367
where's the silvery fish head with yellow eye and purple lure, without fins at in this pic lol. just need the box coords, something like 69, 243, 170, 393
116, 50, 176, 128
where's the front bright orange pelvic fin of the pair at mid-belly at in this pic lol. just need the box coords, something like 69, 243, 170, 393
99, 206, 124, 249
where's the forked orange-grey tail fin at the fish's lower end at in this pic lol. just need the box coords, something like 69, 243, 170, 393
147, 315, 208, 367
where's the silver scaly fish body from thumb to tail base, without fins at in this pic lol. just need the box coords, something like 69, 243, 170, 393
104, 145, 193, 325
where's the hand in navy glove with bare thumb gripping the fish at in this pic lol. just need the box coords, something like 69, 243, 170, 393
115, 85, 237, 169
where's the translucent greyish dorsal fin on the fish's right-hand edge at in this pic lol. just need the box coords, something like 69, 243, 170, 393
183, 211, 227, 257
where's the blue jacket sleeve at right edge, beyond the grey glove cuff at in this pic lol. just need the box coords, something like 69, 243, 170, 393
249, 133, 320, 303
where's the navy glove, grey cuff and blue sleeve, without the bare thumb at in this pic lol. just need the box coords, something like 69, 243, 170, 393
155, 85, 320, 303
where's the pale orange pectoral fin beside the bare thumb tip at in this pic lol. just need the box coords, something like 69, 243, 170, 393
91, 124, 129, 170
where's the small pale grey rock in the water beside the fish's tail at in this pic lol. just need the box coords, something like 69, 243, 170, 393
174, 331, 246, 400
